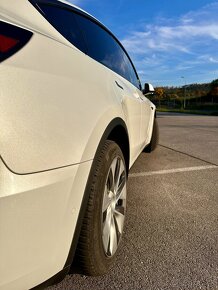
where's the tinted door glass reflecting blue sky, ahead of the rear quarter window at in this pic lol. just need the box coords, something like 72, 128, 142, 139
75, 14, 139, 88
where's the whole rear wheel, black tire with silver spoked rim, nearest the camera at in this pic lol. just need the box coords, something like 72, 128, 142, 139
76, 140, 127, 276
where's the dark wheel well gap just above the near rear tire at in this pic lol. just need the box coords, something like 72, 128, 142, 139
107, 125, 130, 173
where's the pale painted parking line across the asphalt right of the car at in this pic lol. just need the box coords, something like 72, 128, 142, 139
129, 165, 218, 177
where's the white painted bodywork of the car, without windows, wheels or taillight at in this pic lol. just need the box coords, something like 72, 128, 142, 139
0, 0, 155, 290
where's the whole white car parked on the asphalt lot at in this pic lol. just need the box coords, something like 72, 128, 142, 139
0, 0, 157, 290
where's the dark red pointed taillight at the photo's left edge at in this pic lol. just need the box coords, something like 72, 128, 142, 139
0, 21, 33, 62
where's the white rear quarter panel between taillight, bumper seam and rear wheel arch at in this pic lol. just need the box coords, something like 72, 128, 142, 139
0, 28, 127, 173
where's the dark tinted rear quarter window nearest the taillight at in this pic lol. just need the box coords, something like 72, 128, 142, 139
38, 3, 86, 53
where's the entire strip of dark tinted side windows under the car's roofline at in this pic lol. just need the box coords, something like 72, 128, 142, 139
34, 2, 141, 89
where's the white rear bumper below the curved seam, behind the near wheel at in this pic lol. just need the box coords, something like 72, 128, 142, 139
0, 161, 92, 290
